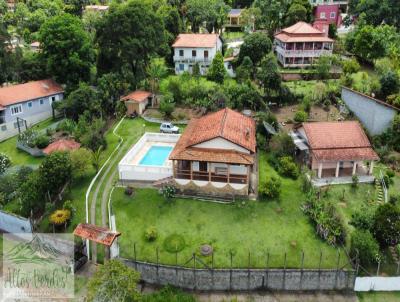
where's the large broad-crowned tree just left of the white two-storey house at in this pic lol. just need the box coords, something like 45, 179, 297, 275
95, 0, 166, 83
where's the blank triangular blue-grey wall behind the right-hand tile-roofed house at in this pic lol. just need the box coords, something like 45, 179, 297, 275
342, 87, 399, 135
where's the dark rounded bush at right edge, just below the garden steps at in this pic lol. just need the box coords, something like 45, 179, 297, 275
372, 203, 400, 247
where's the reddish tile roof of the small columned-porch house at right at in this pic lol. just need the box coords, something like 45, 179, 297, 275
303, 121, 379, 161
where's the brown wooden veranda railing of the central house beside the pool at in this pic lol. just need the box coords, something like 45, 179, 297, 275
174, 169, 247, 184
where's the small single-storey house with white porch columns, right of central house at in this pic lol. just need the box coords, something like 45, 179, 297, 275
292, 121, 379, 182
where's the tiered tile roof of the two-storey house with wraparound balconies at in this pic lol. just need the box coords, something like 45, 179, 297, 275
275, 22, 333, 42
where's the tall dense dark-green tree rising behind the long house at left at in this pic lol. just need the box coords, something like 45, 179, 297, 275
39, 14, 94, 87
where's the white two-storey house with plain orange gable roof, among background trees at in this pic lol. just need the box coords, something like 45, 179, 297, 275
172, 34, 222, 75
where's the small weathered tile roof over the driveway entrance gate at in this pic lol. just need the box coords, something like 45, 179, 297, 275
74, 223, 121, 246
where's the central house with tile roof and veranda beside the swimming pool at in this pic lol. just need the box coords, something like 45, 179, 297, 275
169, 108, 256, 196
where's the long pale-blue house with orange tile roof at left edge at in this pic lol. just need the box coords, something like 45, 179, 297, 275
0, 79, 64, 140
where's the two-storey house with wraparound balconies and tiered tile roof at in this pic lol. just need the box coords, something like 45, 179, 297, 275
274, 22, 334, 68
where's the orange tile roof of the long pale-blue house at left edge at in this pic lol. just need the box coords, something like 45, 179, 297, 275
0, 79, 64, 107
